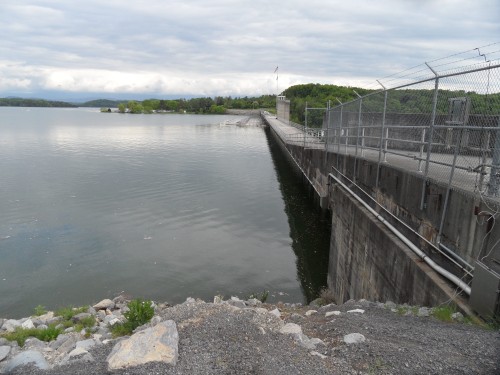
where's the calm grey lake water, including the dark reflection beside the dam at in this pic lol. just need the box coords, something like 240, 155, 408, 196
0, 107, 329, 317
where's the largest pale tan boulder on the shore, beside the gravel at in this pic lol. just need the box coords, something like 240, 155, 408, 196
107, 320, 179, 370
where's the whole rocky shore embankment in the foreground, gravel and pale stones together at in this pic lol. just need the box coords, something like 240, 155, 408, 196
0, 296, 500, 375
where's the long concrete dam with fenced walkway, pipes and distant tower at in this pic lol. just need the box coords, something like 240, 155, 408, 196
262, 60, 500, 319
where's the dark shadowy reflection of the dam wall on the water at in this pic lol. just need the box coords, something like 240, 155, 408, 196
266, 130, 331, 303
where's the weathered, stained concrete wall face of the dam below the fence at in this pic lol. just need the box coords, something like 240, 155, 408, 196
264, 112, 494, 309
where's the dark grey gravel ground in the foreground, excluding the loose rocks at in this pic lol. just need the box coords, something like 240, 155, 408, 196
4, 301, 500, 375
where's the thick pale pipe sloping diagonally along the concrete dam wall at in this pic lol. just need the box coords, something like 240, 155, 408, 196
328, 173, 471, 295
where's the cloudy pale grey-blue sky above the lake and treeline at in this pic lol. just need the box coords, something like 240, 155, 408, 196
0, 0, 500, 100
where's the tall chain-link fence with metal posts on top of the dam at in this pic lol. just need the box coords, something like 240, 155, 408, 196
324, 61, 500, 199
